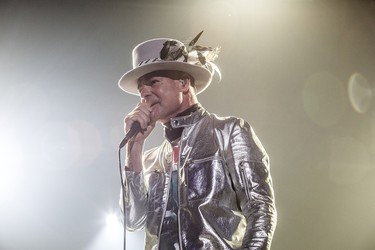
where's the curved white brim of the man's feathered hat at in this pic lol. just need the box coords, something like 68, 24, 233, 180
118, 61, 212, 95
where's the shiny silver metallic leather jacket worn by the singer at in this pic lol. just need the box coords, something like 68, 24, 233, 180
125, 108, 276, 250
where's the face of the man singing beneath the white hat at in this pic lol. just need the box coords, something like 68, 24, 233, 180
138, 76, 183, 123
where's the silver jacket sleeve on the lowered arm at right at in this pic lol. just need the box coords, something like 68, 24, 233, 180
226, 119, 276, 250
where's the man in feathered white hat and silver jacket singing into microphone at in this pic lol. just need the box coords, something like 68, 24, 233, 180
119, 33, 276, 250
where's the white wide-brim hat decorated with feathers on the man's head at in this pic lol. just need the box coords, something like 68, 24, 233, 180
118, 32, 219, 95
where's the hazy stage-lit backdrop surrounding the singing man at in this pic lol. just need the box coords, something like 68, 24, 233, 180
0, 0, 375, 250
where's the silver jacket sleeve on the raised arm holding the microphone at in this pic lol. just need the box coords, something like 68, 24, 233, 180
120, 170, 147, 231
